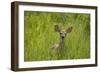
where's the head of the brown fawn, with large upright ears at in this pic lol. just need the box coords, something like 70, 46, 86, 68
55, 25, 72, 39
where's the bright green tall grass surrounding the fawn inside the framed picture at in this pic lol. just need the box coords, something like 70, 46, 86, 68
24, 11, 90, 61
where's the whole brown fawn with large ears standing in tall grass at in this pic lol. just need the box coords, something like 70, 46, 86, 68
52, 25, 72, 58
